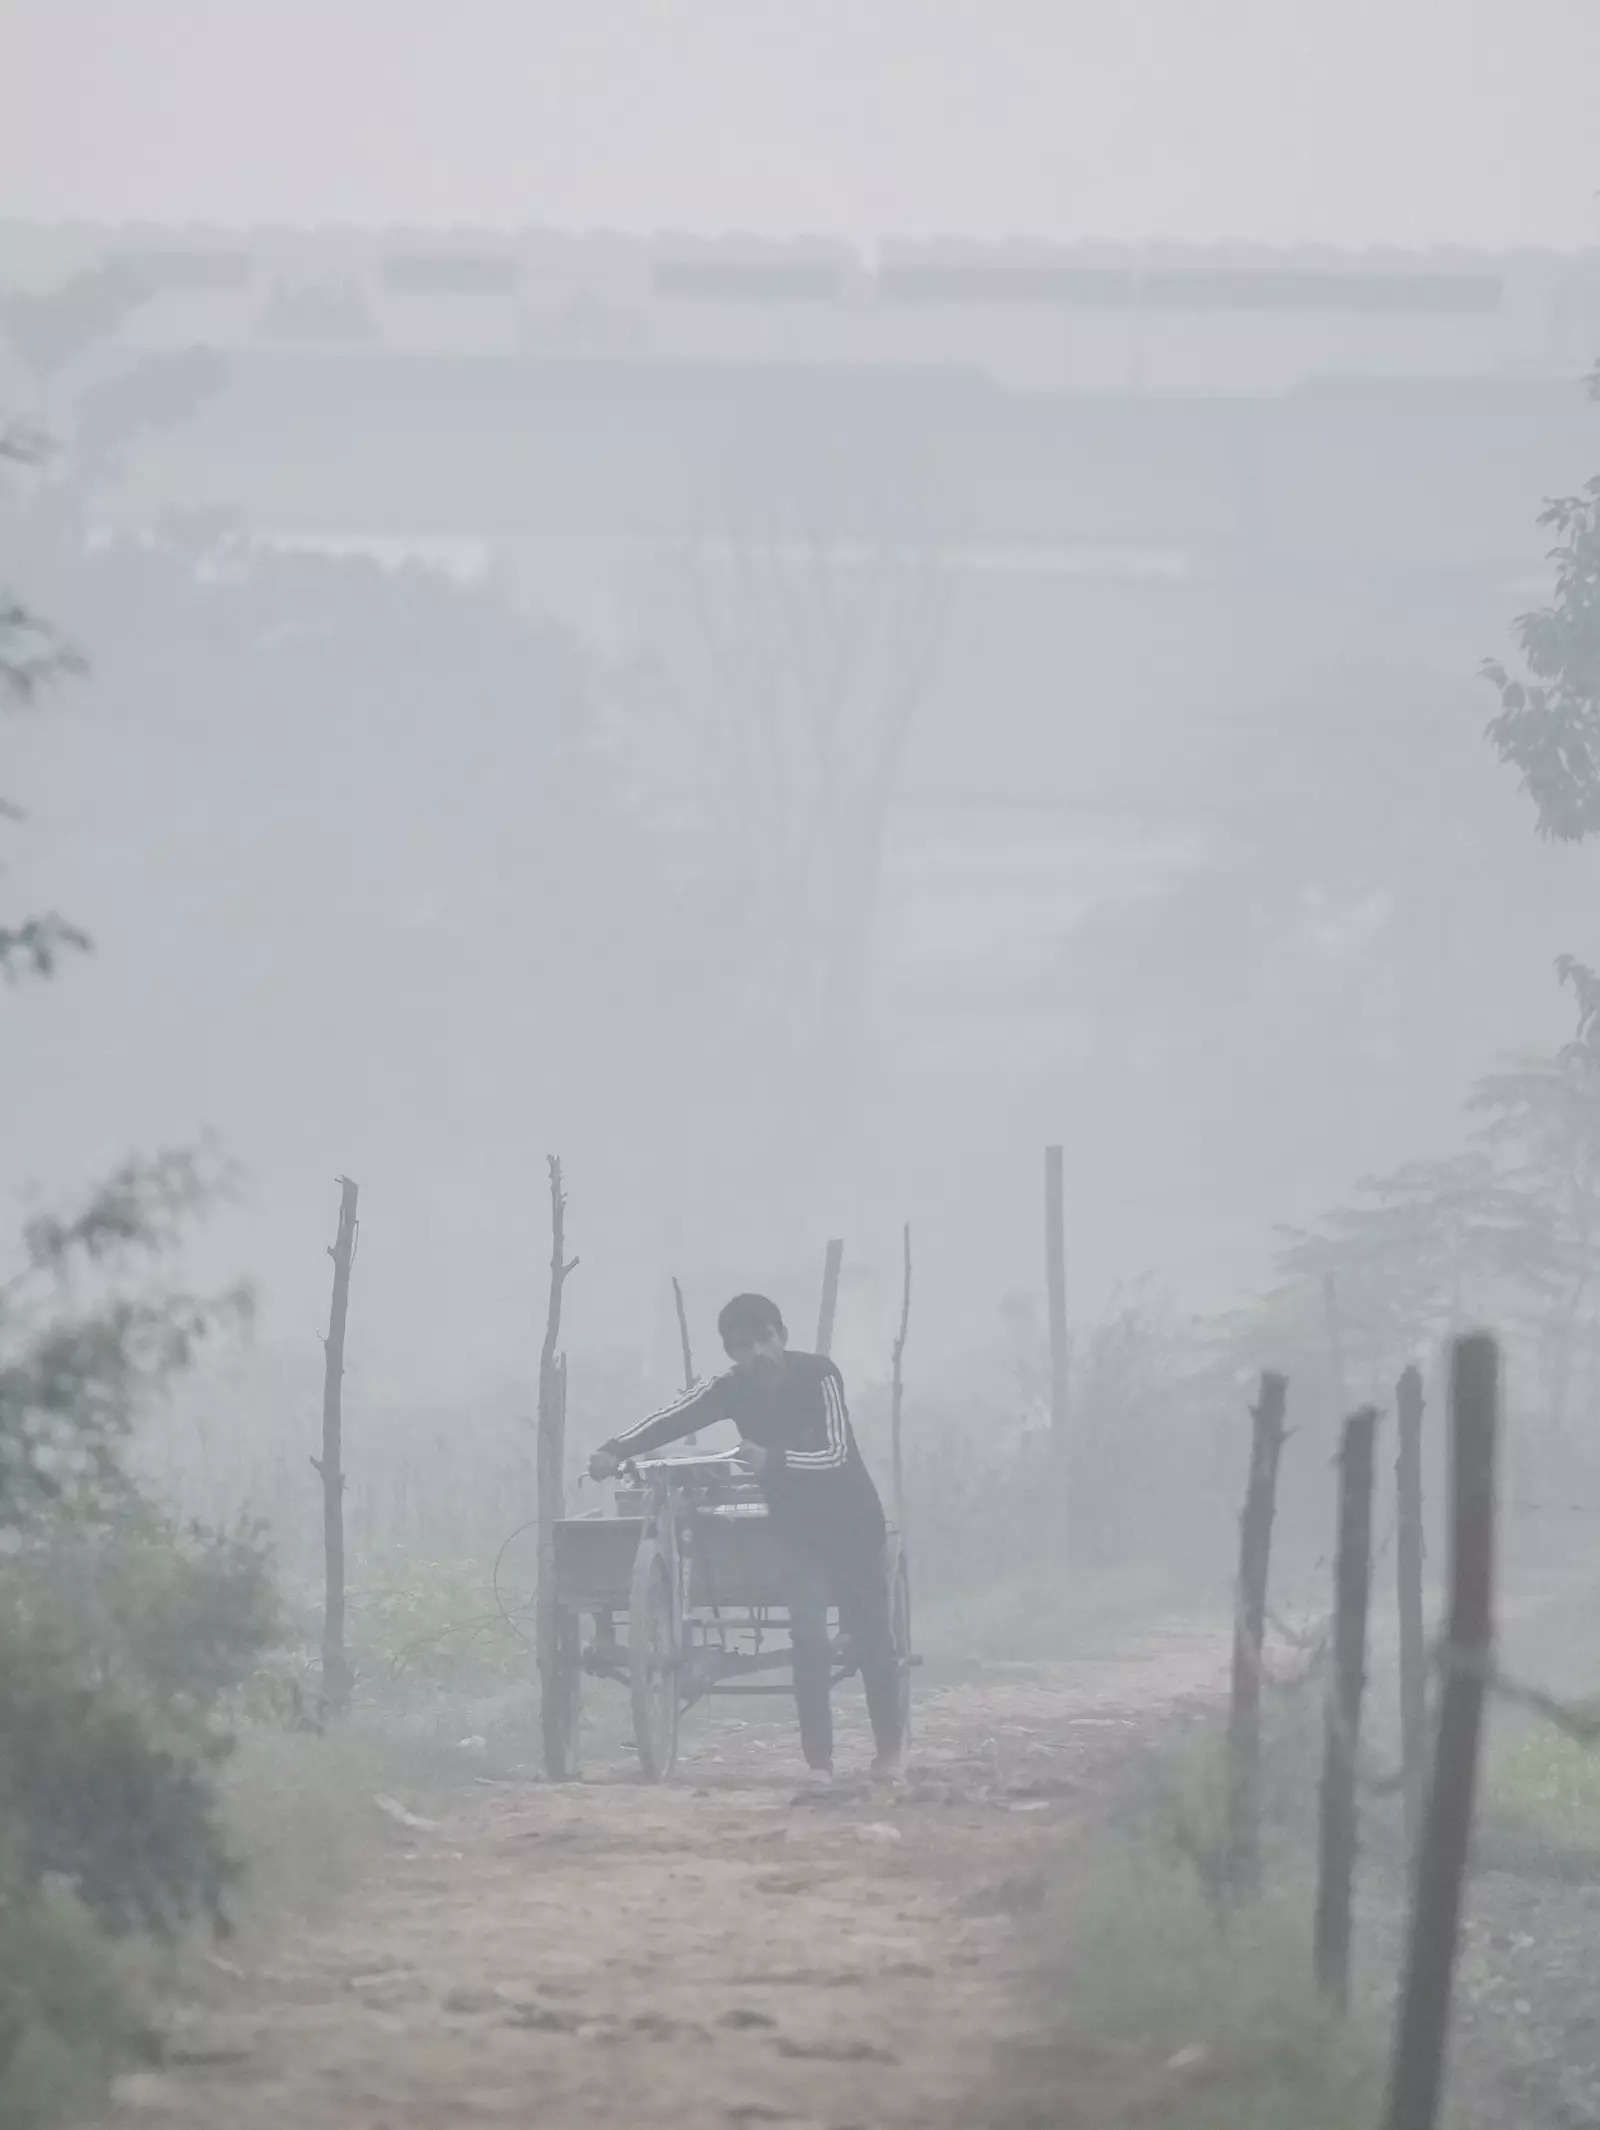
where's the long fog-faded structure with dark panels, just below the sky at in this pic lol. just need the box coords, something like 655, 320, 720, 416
0, 222, 1600, 394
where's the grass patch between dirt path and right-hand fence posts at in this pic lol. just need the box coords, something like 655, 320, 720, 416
978, 1695, 1389, 2130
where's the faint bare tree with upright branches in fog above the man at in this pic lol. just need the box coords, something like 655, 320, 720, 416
643, 417, 954, 1218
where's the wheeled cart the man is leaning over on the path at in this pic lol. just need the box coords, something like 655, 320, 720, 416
541, 1455, 918, 1783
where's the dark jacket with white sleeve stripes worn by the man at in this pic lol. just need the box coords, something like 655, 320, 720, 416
605, 1353, 884, 1544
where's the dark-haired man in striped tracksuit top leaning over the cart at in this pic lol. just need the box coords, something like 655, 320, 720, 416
588, 1295, 903, 1783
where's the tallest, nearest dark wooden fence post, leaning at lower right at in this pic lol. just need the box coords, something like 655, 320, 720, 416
1383, 1331, 1500, 2130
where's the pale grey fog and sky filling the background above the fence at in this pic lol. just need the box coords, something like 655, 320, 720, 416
0, 4, 1600, 1456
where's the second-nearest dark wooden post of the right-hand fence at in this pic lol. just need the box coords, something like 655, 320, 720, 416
1315, 1406, 1378, 2011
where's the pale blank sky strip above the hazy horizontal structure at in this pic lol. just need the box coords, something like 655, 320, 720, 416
0, 0, 1600, 245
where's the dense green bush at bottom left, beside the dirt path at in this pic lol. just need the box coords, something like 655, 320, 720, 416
0, 1500, 277, 2124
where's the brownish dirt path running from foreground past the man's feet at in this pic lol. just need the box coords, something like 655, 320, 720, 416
102, 1632, 1223, 2130
